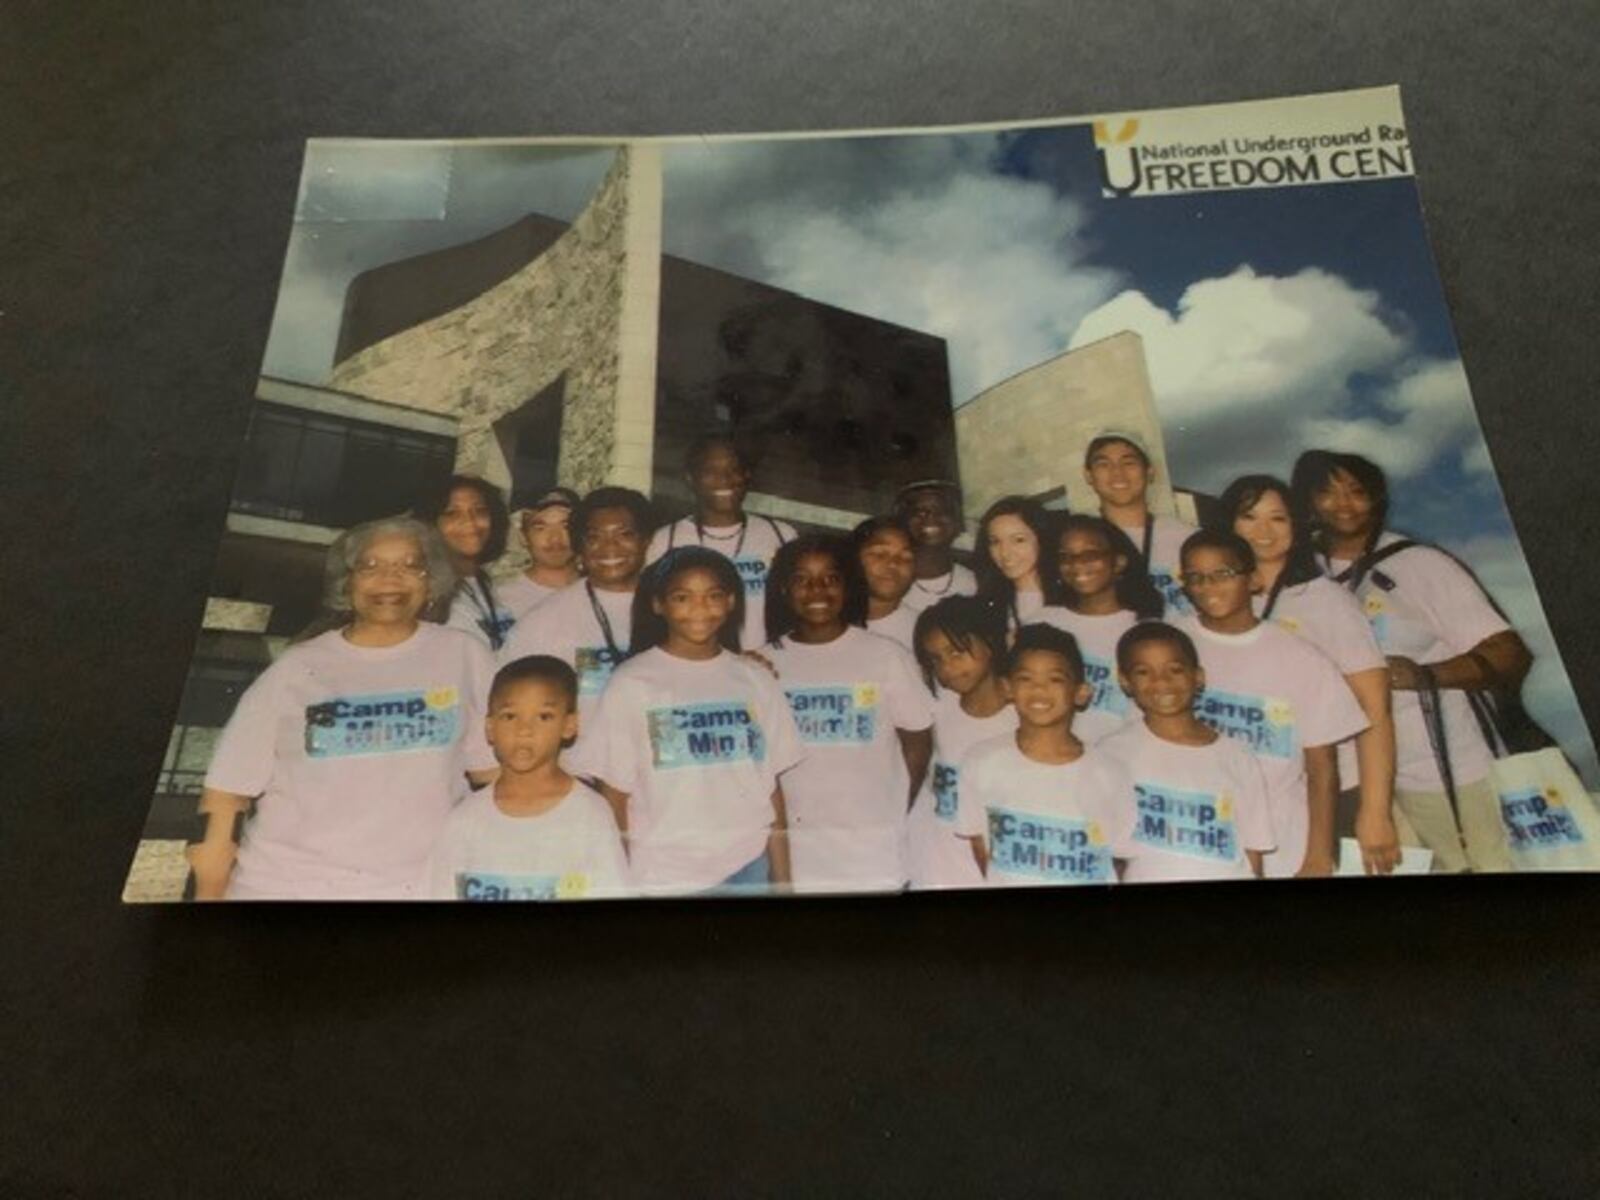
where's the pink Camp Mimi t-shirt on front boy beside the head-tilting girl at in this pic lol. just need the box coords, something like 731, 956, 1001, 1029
955, 734, 1138, 888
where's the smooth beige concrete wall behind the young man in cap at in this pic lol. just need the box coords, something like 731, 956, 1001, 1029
955, 333, 1176, 520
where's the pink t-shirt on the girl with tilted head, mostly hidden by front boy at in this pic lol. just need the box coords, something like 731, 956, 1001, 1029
907, 690, 1016, 888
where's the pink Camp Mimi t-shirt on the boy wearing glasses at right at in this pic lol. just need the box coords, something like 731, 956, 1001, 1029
1178, 618, 1366, 877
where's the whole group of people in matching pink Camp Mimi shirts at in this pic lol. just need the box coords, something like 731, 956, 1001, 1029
181, 432, 1530, 899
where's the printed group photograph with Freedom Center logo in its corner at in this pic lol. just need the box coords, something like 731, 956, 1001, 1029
123, 90, 1600, 902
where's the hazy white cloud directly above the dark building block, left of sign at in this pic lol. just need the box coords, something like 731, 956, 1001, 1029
664, 134, 1117, 402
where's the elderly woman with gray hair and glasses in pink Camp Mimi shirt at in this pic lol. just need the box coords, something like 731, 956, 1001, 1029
189, 518, 494, 899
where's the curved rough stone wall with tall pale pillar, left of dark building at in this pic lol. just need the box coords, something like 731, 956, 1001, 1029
328, 146, 661, 491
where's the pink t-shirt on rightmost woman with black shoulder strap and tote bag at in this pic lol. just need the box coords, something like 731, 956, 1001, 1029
1328, 533, 1510, 792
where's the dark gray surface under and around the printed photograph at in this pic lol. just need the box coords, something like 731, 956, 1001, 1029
0, 0, 1600, 1195
